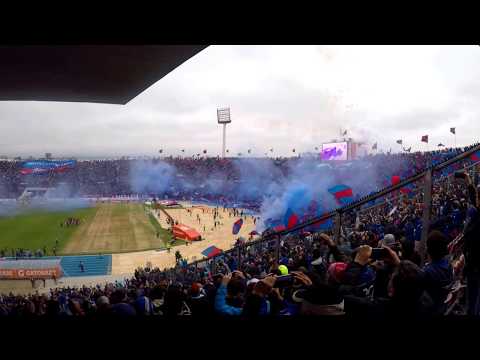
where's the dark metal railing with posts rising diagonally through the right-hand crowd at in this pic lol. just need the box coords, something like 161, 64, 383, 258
179, 143, 480, 272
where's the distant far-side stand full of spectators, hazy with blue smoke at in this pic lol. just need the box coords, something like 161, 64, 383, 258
0, 148, 472, 202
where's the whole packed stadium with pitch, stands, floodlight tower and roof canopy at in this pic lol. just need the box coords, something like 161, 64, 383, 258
0, 47, 480, 317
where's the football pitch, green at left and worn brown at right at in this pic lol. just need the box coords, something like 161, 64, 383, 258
0, 203, 170, 255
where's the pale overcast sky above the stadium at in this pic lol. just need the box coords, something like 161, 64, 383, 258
0, 46, 480, 157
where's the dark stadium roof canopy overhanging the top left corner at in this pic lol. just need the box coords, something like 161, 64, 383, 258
0, 45, 206, 104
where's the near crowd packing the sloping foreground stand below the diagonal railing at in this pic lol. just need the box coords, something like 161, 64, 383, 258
0, 145, 480, 318
